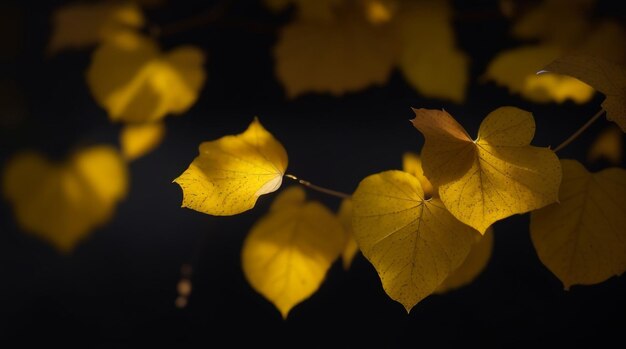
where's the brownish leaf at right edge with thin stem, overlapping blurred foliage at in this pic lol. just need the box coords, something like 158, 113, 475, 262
541, 55, 626, 132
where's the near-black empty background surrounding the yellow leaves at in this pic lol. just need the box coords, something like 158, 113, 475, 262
0, 1, 626, 347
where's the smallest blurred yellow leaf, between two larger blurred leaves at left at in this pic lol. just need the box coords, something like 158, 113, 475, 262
120, 122, 165, 161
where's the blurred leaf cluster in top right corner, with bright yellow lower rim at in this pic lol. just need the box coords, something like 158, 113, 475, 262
485, 0, 626, 103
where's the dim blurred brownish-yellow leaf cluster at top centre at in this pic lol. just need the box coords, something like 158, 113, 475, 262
266, 0, 468, 102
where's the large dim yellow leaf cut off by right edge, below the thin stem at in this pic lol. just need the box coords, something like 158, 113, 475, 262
530, 160, 626, 289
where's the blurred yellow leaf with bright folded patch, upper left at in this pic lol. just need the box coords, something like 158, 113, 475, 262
87, 33, 205, 122
